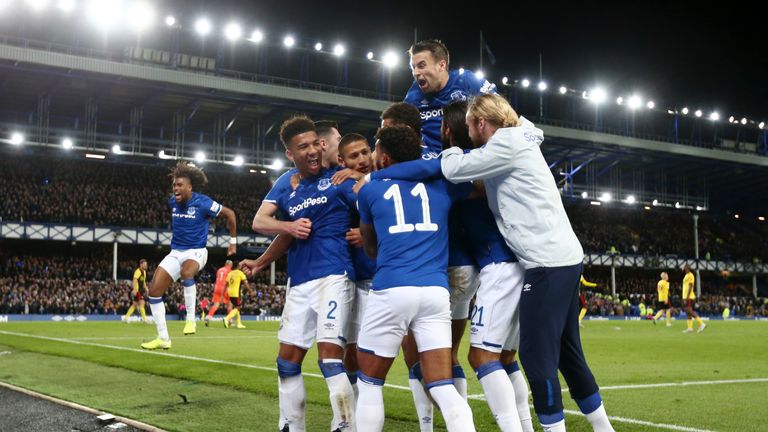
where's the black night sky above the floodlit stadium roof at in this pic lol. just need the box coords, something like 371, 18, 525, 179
168, 0, 768, 120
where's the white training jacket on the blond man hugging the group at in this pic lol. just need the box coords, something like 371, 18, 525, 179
441, 117, 584, 269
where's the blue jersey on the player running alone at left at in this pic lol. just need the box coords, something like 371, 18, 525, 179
168, 192, 222, 250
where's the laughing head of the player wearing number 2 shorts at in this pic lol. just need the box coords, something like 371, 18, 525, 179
280, 116, 323, 176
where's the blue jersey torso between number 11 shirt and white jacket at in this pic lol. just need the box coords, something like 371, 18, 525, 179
452, 197, 517, 268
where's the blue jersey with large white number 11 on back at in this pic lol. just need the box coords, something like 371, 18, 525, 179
357, 180, 470, 290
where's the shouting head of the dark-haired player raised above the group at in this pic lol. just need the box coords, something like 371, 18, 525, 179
408, 39, 450, 93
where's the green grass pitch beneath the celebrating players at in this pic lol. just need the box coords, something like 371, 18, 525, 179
0, 321, 768, 432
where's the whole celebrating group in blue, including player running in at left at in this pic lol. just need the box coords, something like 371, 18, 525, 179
136, 40, 613, 432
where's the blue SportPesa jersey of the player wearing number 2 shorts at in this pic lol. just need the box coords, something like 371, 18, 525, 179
264, 168, 355, 285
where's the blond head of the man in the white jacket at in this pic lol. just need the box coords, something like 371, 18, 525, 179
467, 93, 520, 147
